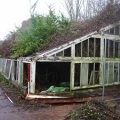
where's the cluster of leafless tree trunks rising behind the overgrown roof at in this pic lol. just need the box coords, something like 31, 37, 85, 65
65, 0, 112, 21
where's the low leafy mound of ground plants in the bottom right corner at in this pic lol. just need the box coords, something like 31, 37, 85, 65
65, 102, 120, 120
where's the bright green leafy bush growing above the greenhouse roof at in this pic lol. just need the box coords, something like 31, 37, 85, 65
13, 10, 70, 58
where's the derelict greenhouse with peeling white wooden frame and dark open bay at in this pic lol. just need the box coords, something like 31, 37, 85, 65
0, 22, 120, 94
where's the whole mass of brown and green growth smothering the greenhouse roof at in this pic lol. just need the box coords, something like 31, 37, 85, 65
0, 0, 120, 58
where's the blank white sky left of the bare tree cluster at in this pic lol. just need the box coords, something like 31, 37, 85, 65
0, 0, 65, 40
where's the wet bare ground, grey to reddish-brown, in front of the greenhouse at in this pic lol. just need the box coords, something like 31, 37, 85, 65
0, 88, 79, 120
